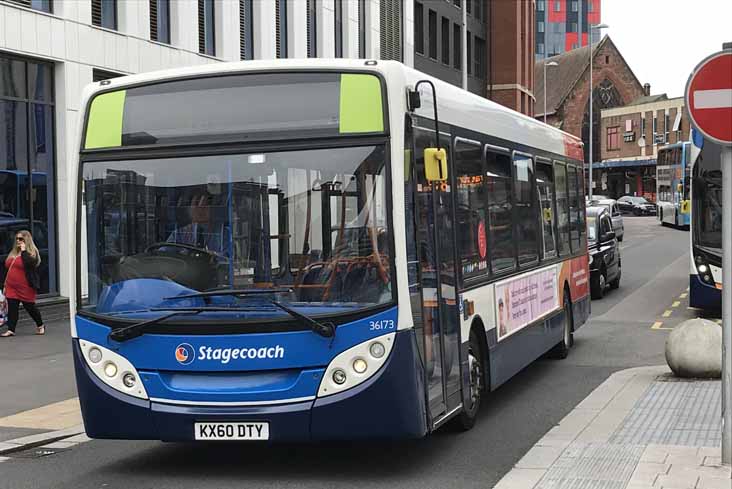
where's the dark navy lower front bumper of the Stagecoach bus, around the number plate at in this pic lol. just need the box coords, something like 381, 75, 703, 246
73, 330, 427, 442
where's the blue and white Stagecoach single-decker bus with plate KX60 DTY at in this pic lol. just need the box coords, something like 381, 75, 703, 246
70, 59, 590, 442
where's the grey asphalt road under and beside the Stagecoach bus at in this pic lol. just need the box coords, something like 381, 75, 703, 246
0, 217, 708, 489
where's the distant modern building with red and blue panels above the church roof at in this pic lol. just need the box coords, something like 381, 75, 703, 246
535, 0, 602, 60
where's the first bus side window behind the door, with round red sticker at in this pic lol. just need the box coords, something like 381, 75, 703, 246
455, 138, 488, 279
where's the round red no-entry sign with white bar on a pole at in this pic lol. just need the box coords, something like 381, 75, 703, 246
685, 50, 732, 145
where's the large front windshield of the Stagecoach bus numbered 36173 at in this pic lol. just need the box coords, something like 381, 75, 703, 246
82, 145, 393, 321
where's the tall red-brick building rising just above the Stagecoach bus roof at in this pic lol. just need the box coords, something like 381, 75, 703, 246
487, 0, 535, 117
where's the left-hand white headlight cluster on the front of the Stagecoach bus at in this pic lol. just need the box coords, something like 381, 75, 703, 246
79, 340, 148, 399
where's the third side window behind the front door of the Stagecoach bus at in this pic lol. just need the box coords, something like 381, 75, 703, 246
513, 153, 539, 266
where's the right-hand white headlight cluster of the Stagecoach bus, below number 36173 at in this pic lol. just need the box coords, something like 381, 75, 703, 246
318, 333, 396, 397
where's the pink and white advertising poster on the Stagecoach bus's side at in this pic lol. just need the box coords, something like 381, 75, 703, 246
495, 267, 559, 341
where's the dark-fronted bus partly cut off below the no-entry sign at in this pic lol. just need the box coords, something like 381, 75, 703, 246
689, 130, 722, 312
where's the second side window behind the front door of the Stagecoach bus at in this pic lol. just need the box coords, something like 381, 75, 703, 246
485, 151, 516, 273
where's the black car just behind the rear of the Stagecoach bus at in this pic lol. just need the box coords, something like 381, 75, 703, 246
587, 206, 621, 299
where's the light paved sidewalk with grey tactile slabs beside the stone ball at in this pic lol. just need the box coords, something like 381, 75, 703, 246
495, 365, 732, 489
